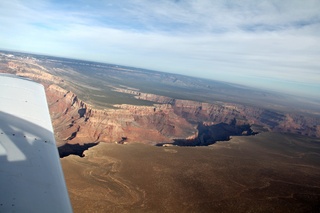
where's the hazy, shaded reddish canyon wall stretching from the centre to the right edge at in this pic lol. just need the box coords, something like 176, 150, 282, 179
131, 89, 320, 137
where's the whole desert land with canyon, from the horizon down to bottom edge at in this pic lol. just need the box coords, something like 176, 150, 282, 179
0, 51, 320, 212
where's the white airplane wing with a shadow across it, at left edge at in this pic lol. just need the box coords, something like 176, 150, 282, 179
0, 74, 72, 212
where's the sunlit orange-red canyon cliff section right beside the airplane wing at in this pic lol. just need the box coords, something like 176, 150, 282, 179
46, 85, 195, 145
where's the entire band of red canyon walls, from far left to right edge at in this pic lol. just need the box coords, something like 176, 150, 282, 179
2, 58, 320, 146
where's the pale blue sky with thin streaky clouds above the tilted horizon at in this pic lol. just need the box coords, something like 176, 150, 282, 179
0, 0, 320, 101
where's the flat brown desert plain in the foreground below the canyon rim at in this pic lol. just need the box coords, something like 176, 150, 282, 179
61, 132, 320, 212
